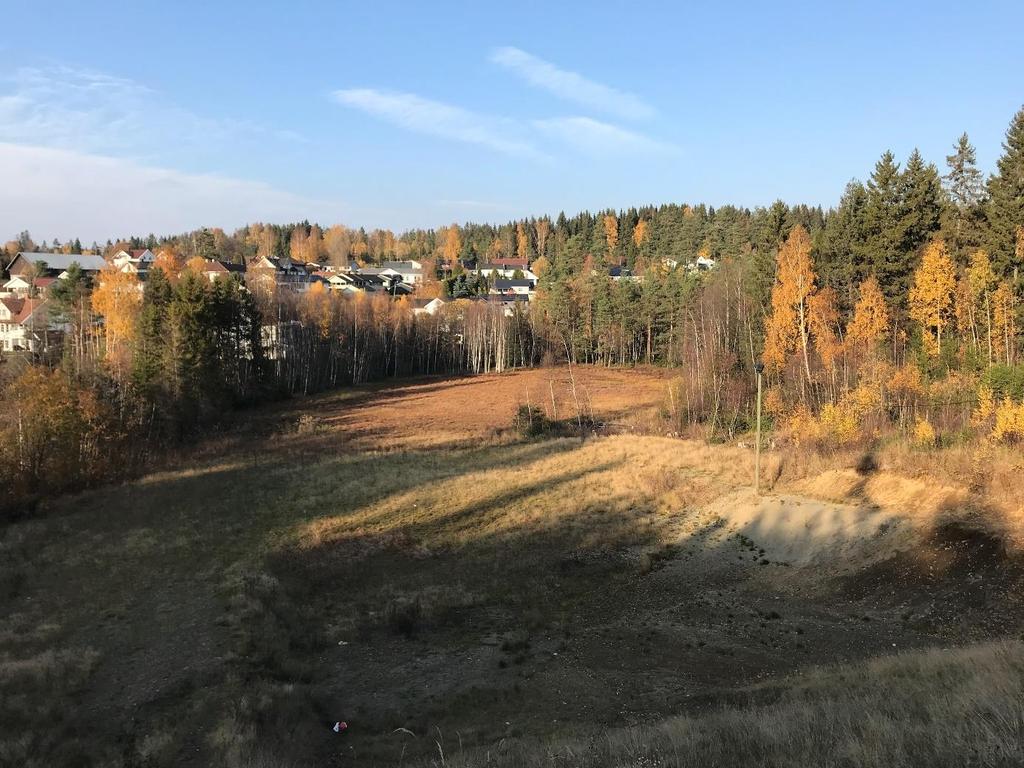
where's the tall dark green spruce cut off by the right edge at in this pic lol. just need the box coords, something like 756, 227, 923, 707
985, 108, 1024, 276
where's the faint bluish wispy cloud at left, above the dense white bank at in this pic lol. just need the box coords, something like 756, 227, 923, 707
0, 66, 302, 161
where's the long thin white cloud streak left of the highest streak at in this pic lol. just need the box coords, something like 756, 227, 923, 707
333, 88, 544, 159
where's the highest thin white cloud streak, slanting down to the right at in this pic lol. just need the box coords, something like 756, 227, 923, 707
490, 46, 656, 120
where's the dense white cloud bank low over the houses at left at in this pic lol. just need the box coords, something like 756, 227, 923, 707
0, 142, 349, 242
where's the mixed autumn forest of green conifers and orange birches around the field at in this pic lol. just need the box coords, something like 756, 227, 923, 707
0, 103, 1024, 512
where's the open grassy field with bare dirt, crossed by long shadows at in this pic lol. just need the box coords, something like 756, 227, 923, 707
0, 369, 1024, 767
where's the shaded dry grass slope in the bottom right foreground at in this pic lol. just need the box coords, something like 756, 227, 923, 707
432, 642, 1024, 768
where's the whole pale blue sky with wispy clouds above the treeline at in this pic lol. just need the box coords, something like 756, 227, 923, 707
0, 0, 1024, 241
